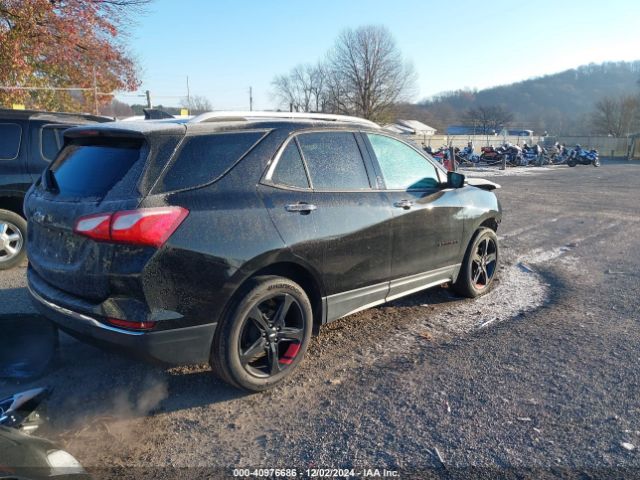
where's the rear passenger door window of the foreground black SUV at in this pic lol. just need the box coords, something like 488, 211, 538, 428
298, 132, 371, 190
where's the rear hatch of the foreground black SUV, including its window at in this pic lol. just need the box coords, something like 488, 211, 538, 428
25, 124, 184, 303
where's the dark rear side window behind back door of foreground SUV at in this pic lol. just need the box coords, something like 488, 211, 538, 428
162, 131, 266, 191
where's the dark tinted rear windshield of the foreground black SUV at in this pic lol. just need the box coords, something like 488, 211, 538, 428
51, 139, 143, 198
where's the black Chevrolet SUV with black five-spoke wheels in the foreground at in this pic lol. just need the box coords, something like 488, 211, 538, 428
25, 113, 501, 391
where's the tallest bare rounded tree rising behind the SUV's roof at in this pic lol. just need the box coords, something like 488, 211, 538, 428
325, 26, 416, 121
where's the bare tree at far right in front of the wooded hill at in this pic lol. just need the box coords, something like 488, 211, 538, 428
593, 95, 640, 137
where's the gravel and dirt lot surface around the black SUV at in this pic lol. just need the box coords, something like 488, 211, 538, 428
0, 163, 640, 478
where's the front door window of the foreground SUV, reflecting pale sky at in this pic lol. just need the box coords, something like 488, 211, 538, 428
367, 133, 439, 190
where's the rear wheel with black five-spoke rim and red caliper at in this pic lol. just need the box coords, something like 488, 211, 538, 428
211, 276, 313, 392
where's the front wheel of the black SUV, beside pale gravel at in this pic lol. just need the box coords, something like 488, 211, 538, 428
453, 228, 499, 298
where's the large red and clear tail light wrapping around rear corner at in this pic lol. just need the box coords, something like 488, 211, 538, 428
73, 207, 189, 248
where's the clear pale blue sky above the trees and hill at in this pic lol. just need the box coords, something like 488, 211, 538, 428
118, 0, 640, 110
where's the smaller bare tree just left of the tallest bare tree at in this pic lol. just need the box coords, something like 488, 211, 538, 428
271, 64, 325, 112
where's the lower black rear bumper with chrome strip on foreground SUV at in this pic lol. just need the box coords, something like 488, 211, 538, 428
28, 279, 217, 365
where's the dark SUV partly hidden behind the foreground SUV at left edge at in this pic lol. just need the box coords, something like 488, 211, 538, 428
0, 109, 110, 270
